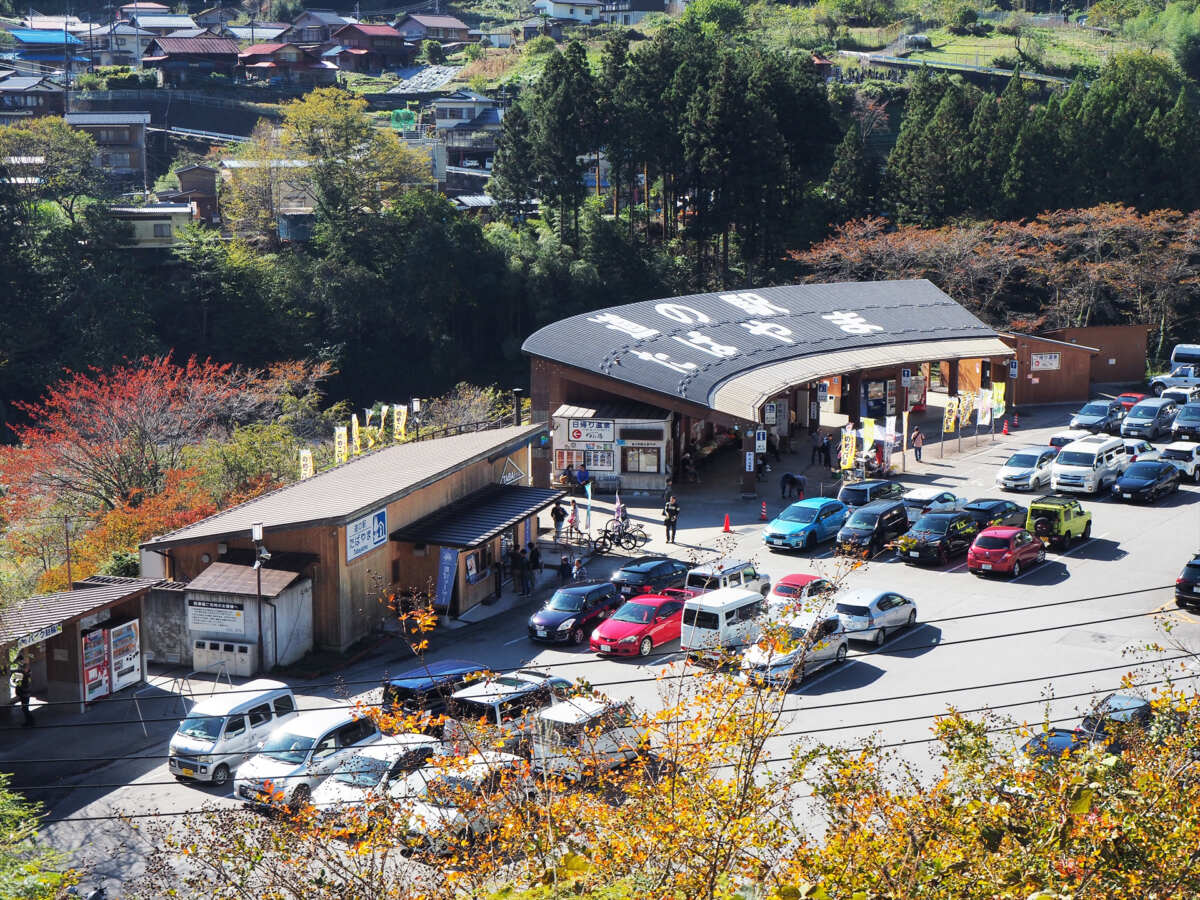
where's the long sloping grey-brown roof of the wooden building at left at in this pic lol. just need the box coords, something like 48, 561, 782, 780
142, 425, 546, 550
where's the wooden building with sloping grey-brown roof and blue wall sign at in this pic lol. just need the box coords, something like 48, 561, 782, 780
142, 425, 563, 672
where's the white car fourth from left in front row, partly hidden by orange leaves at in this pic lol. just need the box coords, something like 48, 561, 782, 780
389, 750, 536, 856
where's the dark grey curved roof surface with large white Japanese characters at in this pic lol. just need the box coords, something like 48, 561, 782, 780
522, 280, 1007, 420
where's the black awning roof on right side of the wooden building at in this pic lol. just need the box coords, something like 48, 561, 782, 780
391, 485, 566, 547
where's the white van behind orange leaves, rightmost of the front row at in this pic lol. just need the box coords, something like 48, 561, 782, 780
529, 697, 646, 781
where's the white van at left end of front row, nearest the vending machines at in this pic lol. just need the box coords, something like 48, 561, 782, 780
167, 678, 296, 785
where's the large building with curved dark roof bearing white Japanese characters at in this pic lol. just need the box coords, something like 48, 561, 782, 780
522, 280, 1013, 492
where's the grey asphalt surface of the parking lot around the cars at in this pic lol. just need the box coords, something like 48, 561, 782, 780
32, 417, 1200, 894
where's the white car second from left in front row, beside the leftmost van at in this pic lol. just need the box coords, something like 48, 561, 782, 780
234, 708, 379, 806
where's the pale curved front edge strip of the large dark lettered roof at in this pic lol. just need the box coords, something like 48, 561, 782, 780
712, 337, 1013, 419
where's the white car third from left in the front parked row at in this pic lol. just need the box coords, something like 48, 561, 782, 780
312, 734, 446, 817
